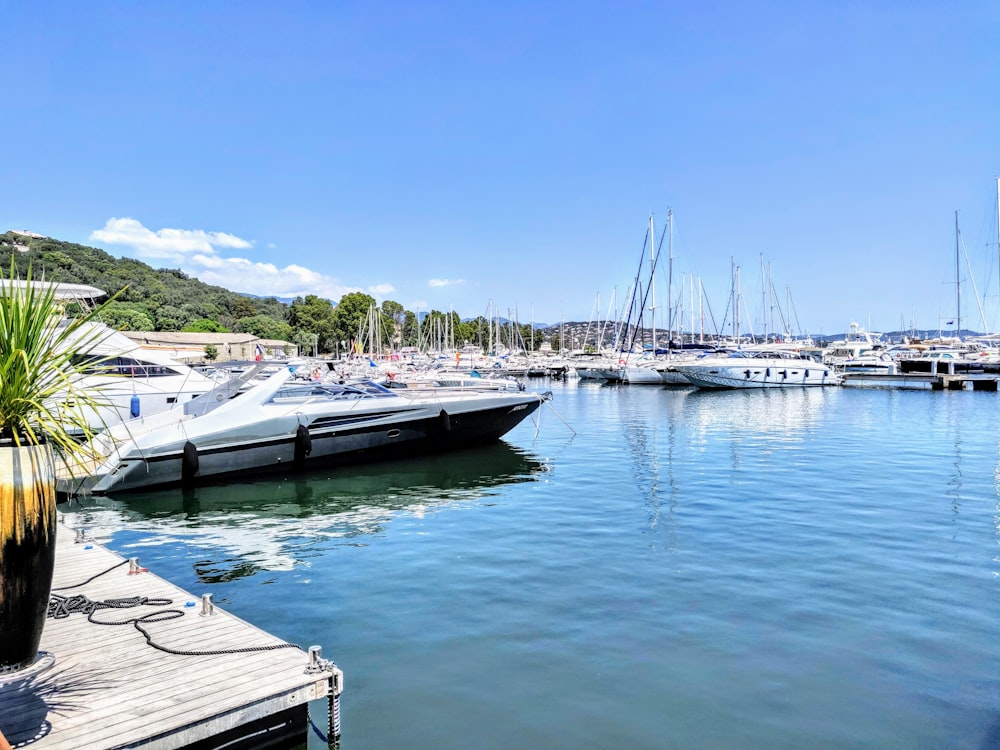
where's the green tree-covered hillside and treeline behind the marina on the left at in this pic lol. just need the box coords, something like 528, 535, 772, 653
0, 232, 556, 353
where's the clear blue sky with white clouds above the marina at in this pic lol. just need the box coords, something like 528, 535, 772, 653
0, 0, 1000, 334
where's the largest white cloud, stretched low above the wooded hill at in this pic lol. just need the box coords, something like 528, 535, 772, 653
90, 219, 358, 302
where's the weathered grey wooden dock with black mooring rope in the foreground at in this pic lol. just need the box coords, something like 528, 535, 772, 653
0, 522, 342, 750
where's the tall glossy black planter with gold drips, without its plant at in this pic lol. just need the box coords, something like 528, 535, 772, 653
0, 445, 56, 674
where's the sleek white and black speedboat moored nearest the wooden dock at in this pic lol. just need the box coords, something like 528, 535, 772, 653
57, 367, 548, 495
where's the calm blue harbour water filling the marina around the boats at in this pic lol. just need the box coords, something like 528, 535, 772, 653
60, 383, 1000, 750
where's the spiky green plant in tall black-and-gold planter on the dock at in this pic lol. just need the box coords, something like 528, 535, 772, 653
0, 259, 115, 674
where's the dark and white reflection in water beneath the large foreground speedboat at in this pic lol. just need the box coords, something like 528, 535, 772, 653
63, 442, 546, 583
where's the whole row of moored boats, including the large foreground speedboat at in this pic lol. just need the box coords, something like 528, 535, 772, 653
48, 326, 1000, 494
